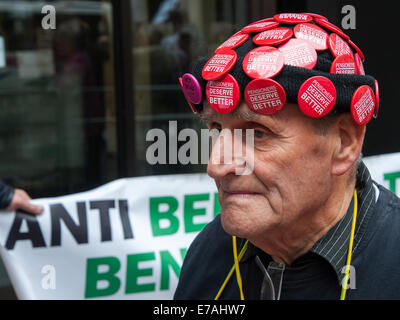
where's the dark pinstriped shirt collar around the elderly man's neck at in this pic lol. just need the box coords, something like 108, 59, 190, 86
242, 162, 375, 283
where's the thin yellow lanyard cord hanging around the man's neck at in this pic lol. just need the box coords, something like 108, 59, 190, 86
214, 190, 358, 300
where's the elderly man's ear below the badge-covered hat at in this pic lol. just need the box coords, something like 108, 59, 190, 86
332, 113, 366, 175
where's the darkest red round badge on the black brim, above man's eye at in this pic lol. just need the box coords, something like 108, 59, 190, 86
244, 79, 286, 114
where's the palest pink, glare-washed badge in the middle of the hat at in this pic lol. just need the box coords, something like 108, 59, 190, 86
279, 39, 318, 69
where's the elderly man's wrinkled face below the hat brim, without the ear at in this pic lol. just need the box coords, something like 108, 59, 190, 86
204, 102, 337, 244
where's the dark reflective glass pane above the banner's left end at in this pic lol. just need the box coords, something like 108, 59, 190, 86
0, 1, 117, 197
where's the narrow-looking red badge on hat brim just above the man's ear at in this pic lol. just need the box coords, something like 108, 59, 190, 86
350, 85, 375, 125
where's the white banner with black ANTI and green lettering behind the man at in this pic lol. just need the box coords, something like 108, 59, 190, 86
0, 153, 400, 300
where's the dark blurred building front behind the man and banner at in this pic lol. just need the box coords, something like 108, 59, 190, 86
0, 0, 400, 299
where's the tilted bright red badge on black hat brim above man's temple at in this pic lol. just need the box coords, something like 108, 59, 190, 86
297, 76, 336, 118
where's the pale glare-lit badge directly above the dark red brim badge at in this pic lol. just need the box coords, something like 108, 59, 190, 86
243, 46, 284, 79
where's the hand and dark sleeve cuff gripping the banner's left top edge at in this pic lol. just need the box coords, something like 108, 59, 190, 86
0, 180, 43, 215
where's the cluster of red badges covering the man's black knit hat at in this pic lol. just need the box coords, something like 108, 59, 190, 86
192, 13, 379, 124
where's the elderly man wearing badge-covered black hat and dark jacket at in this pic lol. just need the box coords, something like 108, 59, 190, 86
175, 14, 400, 299
